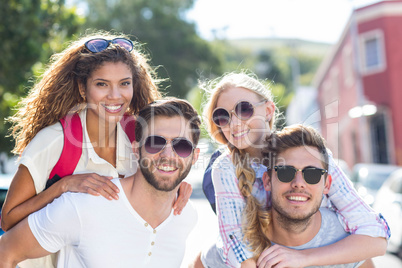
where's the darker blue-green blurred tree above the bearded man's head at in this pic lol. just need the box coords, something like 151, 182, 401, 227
84, 0, 221, 98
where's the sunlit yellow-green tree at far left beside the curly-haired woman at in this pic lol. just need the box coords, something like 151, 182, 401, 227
0, 0, 82, 155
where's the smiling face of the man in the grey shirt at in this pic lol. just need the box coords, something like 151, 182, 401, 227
263, 146, 331, 222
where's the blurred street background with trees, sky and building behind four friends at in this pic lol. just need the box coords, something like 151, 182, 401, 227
0, 0, 402, 267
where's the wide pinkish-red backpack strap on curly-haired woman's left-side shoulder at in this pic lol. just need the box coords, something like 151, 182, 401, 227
46, 113, 83, 189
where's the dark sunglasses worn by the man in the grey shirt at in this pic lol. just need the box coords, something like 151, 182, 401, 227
274, 166, 328, 184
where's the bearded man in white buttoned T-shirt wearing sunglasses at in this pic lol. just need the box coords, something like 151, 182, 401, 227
0, 98, 200, 268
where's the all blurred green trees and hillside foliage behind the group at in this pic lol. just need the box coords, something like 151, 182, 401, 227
0, 0, 328, 157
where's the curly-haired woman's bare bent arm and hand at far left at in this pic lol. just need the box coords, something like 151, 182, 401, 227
1, 165, 119, 231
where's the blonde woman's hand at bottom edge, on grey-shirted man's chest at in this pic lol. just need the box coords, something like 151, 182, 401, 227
257, 245, 307, 268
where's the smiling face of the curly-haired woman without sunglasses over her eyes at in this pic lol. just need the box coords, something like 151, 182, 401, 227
80, 62, 133, 122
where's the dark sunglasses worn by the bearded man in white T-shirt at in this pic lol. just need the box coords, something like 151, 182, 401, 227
144, 135, 194, 158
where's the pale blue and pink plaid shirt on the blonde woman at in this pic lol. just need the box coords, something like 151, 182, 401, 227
212, 151, 390, 267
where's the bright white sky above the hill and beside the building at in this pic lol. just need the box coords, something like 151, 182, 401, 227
186, 0, 379, 44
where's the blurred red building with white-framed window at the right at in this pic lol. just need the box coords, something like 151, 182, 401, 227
314, 0, 402, 167
